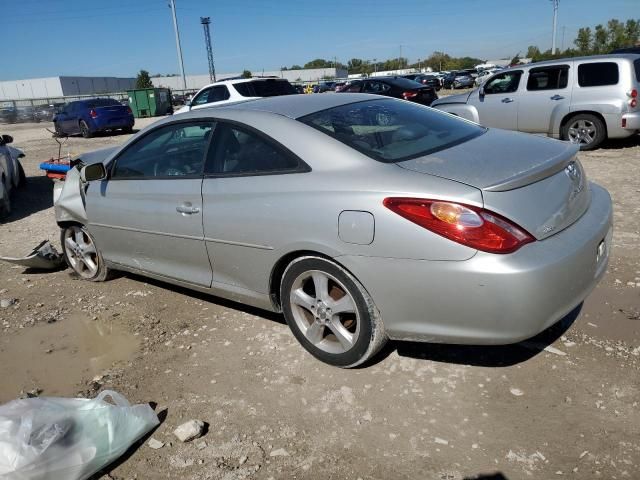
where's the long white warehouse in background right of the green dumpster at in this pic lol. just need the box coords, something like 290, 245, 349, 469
151, 68, 347, 90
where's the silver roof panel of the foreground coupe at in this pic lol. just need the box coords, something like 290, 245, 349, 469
181, 93, 385, 119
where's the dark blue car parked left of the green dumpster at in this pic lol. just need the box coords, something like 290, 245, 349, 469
53, 98, 135, 138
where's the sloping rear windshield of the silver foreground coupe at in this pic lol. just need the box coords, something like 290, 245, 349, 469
299, 99, 486, 163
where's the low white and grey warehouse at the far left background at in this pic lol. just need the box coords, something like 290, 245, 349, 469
0, 77, 136, 100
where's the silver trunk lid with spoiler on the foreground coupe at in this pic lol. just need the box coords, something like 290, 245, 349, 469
397, 129, 591, 240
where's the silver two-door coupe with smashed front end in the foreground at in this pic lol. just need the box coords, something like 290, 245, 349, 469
55, 92, 612, 367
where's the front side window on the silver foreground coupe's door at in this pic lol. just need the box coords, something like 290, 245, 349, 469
111, 122, 213, 179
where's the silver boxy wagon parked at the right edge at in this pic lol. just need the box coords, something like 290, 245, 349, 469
433, 54, 640, 150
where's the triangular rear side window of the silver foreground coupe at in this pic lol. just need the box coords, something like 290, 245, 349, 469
212, 125, 299, 174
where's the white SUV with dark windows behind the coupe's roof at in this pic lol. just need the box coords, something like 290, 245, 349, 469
174, 78, 298, 115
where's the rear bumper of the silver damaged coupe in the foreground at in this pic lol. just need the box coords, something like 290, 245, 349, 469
337, 184, 613, 345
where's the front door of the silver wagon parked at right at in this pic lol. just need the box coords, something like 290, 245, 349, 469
467, 70, 522, 130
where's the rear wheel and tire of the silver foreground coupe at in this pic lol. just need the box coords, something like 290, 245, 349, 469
280, 256, 387, 368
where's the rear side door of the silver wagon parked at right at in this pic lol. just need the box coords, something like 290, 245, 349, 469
518, 63, 574, 133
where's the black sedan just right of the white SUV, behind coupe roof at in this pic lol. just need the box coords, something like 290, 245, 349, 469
340, 77, 438, 106
